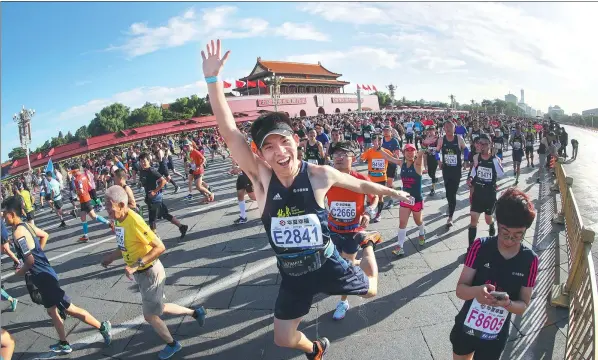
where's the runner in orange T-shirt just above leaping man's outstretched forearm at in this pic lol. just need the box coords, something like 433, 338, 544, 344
361, 134, 402, 223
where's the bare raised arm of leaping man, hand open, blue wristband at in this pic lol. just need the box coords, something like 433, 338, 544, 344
201, 40, 258, 179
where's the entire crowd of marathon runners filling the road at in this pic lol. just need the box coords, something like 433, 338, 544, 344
2, 41, 578, 359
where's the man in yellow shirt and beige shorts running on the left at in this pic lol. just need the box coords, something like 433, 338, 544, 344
102, 185, 206, 359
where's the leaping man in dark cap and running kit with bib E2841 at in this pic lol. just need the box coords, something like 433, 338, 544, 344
201, 40, 411, 360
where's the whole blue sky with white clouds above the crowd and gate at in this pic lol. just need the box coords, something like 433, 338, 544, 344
1, 2, 598, 160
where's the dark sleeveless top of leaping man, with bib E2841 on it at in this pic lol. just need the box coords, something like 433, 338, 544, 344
262, 161, 330, 254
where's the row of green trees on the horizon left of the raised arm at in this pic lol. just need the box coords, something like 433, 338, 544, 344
8, 95, 212, 161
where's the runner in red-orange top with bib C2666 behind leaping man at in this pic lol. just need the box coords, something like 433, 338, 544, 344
326, 141, 382, 320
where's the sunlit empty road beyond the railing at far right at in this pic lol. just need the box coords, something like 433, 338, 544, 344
565, 126, 598, 268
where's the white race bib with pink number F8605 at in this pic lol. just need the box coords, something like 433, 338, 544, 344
463, 299, 509, 340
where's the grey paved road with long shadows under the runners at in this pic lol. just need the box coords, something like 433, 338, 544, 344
2, 147, 568, 360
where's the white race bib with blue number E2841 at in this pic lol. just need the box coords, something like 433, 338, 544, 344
270, 214, 324, 248
